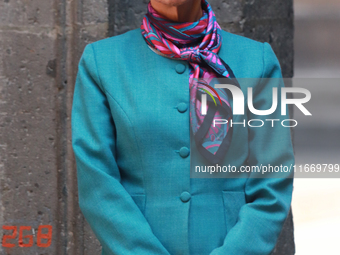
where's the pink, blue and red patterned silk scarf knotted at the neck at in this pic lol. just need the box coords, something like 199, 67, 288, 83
141, 0, 239, 164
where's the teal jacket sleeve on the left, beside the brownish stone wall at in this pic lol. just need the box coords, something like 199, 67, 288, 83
71, 44, 169, 255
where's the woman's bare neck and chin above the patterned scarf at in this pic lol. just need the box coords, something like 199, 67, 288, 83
150, 0, 203, 22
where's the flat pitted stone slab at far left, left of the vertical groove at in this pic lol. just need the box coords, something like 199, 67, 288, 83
0, 1, 58, 254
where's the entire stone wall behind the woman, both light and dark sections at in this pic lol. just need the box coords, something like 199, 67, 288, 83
0, 0, 294, 255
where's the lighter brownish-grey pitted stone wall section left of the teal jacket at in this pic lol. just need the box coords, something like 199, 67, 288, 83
0, 0, 108, 255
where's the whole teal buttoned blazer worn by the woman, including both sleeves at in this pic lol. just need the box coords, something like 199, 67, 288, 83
71, 28, 294, 255
